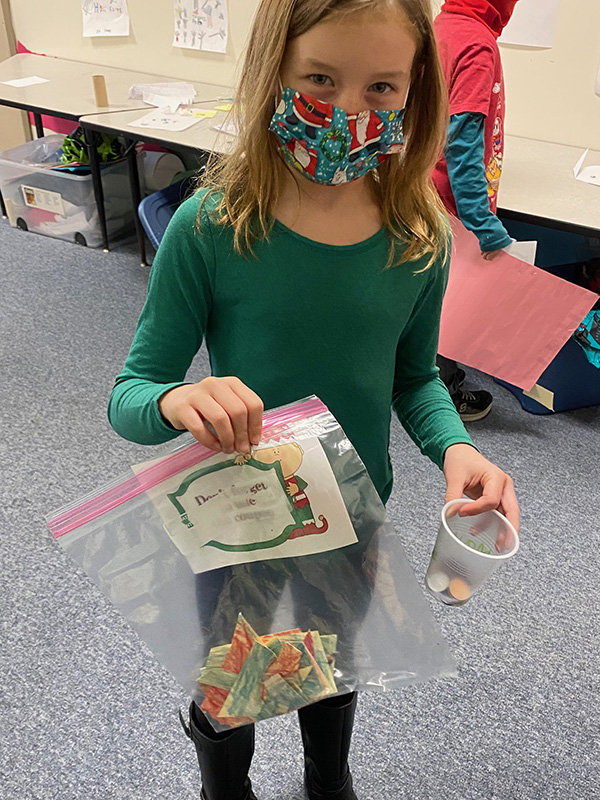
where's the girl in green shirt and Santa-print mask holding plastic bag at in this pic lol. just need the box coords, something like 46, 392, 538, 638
109, 0, 518, 800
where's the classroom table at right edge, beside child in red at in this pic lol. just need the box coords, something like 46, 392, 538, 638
498, 136, 600, 238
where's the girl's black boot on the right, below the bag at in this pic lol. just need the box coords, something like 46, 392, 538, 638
298, 692, 357, 800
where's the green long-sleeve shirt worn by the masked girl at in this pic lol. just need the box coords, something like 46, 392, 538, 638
109, 193, 472, 502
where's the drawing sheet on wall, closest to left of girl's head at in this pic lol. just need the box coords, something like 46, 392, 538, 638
173, 0, 229, 53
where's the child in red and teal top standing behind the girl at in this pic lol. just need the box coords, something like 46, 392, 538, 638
433, 0, 517, 422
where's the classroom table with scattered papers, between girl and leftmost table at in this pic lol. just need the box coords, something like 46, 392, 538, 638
79, 106, 235, 267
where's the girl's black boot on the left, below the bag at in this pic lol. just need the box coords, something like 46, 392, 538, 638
179, 703, 256, 800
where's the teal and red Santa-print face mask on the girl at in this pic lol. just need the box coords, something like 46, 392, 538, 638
269, 88, 405, 185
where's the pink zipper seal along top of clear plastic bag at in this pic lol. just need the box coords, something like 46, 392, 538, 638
48, 397, 329, 539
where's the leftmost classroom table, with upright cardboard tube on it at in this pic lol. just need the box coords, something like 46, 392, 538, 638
0, 53, 231, 250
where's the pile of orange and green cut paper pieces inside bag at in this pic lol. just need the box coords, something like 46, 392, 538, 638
198, 612, 337, 727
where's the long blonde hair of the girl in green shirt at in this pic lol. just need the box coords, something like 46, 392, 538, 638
198, 0, 449, 268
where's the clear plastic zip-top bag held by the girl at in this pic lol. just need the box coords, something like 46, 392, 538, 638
48, 397, 455, 730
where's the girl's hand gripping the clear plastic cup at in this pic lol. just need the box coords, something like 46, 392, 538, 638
444, 443, 519, 533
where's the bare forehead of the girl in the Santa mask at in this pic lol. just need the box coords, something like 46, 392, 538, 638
286, 7, 417, 74
